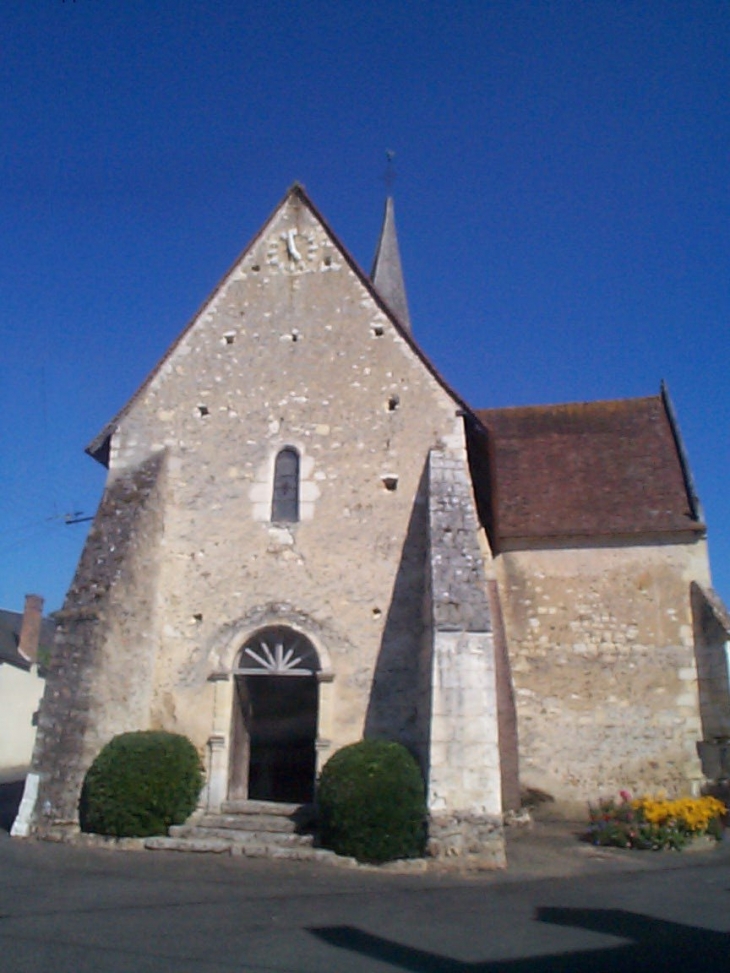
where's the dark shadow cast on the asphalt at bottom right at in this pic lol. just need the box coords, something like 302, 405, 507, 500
309, 908, 730, 973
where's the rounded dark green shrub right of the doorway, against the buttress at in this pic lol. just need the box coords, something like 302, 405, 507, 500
317, 740, 426, 863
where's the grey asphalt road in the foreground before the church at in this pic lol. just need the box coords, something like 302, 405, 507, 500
0, 833, 730, 973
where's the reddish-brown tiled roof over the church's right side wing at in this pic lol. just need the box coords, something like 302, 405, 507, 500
472, 395, 704, 549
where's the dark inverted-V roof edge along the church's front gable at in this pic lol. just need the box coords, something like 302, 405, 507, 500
85, 182, 476, 467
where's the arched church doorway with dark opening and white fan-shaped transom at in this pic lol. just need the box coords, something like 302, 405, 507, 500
229, 625, 320, 803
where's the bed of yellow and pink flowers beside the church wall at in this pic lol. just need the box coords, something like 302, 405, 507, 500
589, 791, 727, 851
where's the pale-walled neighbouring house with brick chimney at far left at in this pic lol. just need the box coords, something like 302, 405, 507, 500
0, 595, 54, 782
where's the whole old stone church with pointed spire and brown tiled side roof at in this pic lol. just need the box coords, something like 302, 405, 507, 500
16, 185, 730, 861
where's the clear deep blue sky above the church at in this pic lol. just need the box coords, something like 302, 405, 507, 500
0, 0, 730, 609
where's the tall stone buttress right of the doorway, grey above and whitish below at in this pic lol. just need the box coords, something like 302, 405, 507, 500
425, 449, 505, 865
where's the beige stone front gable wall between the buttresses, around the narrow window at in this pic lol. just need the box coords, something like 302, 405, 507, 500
112, 194, 461, 760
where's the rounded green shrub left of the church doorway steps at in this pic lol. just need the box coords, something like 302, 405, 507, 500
79, 730, 203, 838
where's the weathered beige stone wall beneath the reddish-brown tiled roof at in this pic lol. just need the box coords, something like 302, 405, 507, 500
495, 540, 707, 807
